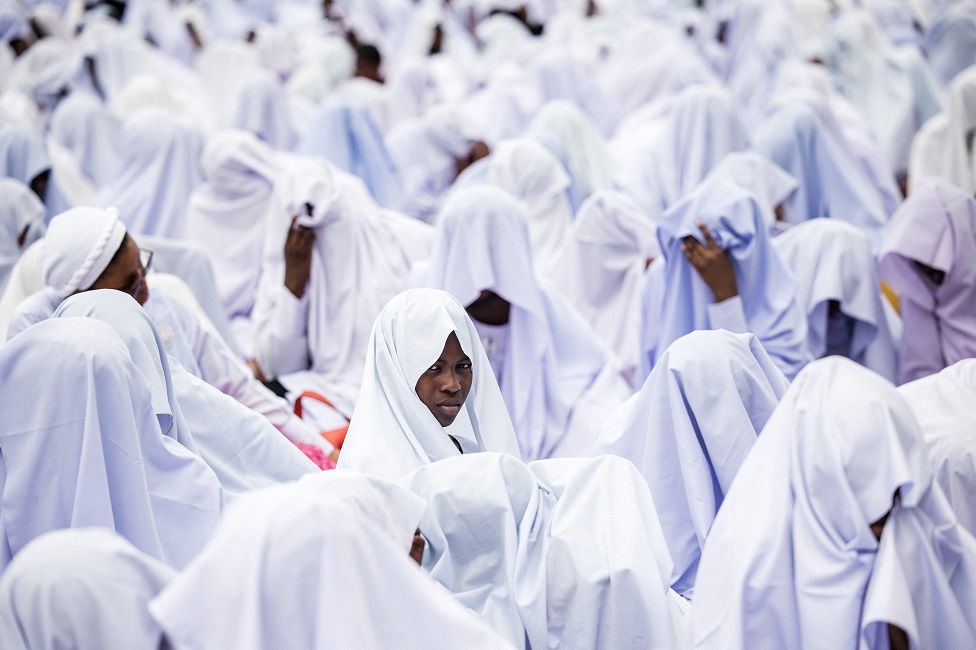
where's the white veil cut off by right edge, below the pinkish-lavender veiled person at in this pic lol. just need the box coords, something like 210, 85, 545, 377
898, 359, 976, 535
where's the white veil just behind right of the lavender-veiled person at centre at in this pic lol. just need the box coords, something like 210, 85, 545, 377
485, 138, 573, 269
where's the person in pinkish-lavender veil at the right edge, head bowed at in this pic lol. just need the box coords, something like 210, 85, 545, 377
878, 178, 976, 382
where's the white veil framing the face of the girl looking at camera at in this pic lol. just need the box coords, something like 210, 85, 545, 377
339, 289, 519, 478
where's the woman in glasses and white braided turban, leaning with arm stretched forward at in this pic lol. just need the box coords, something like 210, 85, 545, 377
7, 208, 336, 466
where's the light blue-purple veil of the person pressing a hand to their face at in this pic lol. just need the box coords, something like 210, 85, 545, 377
644, 179, 809, 377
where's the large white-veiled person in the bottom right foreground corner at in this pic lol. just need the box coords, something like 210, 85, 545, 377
691, 357, 976, 649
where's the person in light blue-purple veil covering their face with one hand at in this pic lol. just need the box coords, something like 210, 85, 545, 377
641, 178, 809, 378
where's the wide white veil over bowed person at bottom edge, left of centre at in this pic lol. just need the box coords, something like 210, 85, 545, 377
149, 470, 508, 650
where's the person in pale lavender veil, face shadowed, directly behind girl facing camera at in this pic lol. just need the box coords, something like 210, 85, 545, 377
426, 186, 631, 460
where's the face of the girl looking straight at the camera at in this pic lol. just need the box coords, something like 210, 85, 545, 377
414, 332, 473, 428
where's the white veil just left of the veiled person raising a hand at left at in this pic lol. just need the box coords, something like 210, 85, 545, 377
186, 130, 279, 318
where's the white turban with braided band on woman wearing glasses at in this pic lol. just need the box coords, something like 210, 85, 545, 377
41, 208, 125, 297
